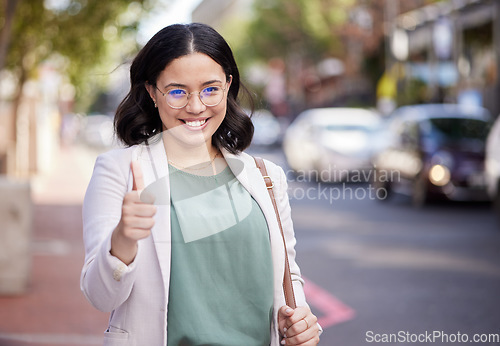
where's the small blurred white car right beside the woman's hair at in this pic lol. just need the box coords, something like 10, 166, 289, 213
252, 109, 283, 146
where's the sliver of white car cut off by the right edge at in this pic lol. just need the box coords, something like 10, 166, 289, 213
486, 116, 500, 221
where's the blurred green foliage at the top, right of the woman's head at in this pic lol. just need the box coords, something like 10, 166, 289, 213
248, 0, 355, 60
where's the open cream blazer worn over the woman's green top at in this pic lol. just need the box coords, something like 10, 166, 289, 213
80, 138, 306, 346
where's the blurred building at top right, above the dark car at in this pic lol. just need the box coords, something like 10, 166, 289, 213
387, 0, 500, 115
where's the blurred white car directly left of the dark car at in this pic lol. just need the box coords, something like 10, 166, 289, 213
283, 107, 381, 182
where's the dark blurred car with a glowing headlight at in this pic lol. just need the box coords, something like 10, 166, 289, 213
374, 104, 491, 206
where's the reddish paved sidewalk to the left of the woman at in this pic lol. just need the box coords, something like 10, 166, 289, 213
0, 147, 108, 346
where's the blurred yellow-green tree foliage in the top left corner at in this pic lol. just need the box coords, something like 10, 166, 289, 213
6, 0, 153, 111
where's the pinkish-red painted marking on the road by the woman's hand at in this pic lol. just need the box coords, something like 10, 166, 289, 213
302, 277, 355, 329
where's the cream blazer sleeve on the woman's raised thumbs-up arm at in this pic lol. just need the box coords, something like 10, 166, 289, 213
80, 149, 140, 312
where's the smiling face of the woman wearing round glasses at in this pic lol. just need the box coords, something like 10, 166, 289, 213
147, 53, 231, 147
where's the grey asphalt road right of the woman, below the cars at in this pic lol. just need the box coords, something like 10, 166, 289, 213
251, 149, 500, 346
